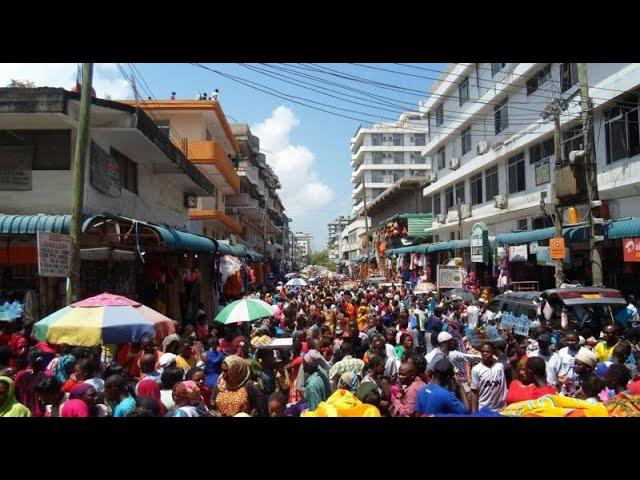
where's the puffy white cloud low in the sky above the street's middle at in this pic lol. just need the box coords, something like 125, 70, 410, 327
251, 106, 334, 224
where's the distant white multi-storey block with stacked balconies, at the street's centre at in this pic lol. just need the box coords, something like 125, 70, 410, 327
351, 112, 431, 215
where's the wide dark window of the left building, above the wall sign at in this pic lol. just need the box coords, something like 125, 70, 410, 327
0, 130, 71, 170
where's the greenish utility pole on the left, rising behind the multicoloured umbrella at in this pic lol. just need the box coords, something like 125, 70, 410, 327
67, 63, 93, 304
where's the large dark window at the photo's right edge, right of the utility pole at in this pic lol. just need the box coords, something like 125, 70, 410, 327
604, 105, 640, 163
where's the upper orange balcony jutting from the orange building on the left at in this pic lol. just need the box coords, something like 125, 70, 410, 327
188, 140, 240, 194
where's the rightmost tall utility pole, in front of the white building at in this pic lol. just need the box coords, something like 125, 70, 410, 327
578, 63, 603, 285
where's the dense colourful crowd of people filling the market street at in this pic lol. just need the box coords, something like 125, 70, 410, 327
0, 281, 640, 417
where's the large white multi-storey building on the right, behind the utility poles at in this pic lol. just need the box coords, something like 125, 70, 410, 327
421, 63, 640, 241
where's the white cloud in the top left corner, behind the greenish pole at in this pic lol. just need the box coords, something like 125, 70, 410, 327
0, 63, 132, 100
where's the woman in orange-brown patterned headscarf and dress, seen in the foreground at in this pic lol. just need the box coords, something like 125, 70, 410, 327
211, 355, 267, 417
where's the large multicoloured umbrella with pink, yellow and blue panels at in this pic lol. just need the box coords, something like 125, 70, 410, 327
33, 293, 175, 347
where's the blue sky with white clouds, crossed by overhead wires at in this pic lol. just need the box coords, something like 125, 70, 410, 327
0, 63, 445, 250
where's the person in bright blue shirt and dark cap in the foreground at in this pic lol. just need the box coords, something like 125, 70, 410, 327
415, 358, 469, 417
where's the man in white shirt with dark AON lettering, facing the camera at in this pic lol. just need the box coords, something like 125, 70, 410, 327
471, 343, 507, 410
